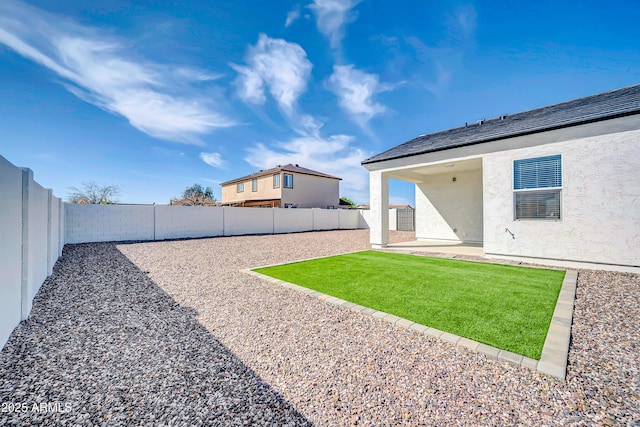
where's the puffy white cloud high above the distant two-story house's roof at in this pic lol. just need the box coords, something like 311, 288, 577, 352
231, 34, 313, 116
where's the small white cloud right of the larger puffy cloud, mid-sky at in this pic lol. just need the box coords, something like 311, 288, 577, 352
326, 65, 391, 126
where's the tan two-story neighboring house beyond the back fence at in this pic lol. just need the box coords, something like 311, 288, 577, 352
220, 164, 341, 209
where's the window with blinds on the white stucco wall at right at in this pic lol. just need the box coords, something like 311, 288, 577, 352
513, 154, 562, 220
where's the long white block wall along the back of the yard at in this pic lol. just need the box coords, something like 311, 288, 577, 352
64, 203, 368, 243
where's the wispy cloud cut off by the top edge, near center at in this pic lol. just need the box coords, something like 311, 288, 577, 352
309, 0, 360, 48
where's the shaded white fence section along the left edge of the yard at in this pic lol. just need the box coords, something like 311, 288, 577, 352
0, 156, 64, 348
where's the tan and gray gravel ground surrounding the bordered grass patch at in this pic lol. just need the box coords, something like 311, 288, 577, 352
0, 230, 640, 426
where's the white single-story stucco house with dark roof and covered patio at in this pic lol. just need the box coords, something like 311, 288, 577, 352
362, 85, 640, 272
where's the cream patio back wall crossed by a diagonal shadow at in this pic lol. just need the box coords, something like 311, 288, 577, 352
415, 169, 482, 243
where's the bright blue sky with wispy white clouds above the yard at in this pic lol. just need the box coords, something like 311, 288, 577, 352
0, 0, 640, 204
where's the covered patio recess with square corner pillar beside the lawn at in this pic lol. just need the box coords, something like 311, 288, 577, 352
366, 156, 484, 251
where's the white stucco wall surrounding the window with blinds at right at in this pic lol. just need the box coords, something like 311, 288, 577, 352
483, 130, 640, 266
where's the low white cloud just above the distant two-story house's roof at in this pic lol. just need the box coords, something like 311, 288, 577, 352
245, 135, 372, 201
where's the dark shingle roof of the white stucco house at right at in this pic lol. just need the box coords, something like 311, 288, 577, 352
362, 84, 640, 165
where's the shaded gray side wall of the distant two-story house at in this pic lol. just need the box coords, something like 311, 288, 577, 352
281, 172, 340, 209
